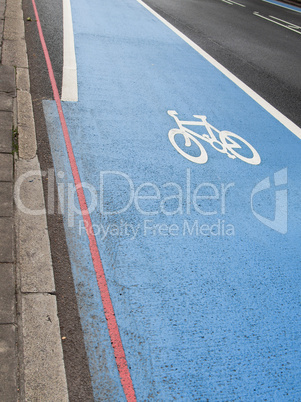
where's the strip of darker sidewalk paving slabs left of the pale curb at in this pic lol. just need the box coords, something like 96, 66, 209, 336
0, 0, 18, 401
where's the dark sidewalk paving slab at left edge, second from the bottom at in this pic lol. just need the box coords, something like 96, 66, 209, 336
0, 264, 16, 324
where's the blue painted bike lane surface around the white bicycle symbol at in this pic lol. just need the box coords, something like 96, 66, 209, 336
44, 0, 301, 401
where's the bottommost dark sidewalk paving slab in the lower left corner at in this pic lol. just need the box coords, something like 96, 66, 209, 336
0, 325, 18, 402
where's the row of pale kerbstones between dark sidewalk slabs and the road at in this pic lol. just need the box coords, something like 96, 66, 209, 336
2, 0, 68, 401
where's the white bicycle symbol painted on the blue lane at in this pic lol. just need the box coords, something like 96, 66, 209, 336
167, 110, 261, 165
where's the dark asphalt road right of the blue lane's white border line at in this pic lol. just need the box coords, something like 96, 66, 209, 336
145, 0, 301, 126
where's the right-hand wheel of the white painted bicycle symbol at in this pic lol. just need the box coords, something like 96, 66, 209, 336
219, 131, 261, 165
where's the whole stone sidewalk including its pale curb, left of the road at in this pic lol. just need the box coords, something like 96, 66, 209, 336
0, 0, 68, 402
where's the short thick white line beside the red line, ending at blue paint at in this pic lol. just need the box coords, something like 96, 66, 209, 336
61, 0, 78, 102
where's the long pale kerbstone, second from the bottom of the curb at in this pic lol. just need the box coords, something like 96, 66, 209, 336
15, 157, 55, 293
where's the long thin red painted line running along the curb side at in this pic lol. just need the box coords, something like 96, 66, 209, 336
32, 0, 136, 402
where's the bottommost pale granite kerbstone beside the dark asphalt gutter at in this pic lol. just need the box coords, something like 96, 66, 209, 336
22, 294, 68, 402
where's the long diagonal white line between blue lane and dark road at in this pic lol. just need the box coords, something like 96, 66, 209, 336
137, 0, 301, 139
